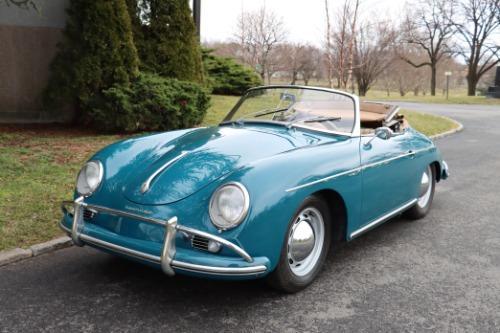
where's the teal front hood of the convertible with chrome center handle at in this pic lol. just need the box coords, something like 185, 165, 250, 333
122, 126, 331, 205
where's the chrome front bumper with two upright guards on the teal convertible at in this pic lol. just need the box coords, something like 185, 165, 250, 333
60, 197, 267, 276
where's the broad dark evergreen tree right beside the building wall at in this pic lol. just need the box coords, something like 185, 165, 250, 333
44, 0, 139, 116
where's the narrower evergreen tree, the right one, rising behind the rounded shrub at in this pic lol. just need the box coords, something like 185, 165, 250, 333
139, 0, 203, 82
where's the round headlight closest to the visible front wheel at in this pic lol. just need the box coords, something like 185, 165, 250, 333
209, 183, 250, 230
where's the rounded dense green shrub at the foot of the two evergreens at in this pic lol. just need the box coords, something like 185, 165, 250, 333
87, 73, 210, 132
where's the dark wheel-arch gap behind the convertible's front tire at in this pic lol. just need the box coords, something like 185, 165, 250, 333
312, 189, 347, 242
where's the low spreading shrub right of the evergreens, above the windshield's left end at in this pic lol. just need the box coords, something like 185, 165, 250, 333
203, 50, 262, 96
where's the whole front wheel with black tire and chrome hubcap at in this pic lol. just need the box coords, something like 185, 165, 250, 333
268, 196, 332, 293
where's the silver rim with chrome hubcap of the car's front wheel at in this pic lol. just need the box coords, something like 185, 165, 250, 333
287, 207, 325, 276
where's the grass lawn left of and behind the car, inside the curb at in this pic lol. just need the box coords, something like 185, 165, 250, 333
0, 96, 455, 250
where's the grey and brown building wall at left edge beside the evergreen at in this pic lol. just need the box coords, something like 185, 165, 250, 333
0, 0, 73, 123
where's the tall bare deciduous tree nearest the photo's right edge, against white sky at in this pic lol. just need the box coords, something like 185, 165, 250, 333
453, 0, 500, 96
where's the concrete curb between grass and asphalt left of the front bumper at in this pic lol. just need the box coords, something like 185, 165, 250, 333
0, 236, 73, 267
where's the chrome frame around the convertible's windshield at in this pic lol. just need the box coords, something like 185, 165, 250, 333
221, 85, 361, 137
